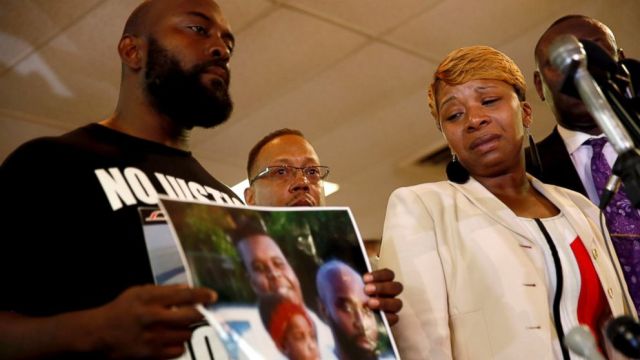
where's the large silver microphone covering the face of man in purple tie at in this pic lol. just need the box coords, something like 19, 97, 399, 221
549, 35, 633, 154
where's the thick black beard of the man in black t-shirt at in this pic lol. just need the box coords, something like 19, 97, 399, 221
144, 37, 233, 129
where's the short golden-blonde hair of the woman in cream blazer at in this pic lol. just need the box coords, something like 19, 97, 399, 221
428, 45, 527, 129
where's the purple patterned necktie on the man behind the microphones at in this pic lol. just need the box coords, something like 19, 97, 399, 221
584, 137, 640, 312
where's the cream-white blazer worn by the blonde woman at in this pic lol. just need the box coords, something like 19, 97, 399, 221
378, 177, 635, 359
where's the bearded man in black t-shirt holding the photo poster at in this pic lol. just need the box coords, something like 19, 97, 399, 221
0, 0, 241, 359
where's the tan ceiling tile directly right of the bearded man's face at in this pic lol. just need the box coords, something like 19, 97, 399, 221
222, 9, 365, 116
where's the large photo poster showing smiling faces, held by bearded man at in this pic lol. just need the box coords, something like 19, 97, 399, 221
159, 198, 399, 359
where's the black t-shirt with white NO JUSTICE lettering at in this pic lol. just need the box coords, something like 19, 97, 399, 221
0, 124, 242, 316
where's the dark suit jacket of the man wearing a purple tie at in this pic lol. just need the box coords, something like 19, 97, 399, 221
525, 127, 588, 197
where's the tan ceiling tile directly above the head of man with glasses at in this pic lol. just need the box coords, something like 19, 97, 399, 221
191, 43, 428, 167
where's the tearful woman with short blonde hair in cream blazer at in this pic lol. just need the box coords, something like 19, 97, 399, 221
380, 46, 635, 359
